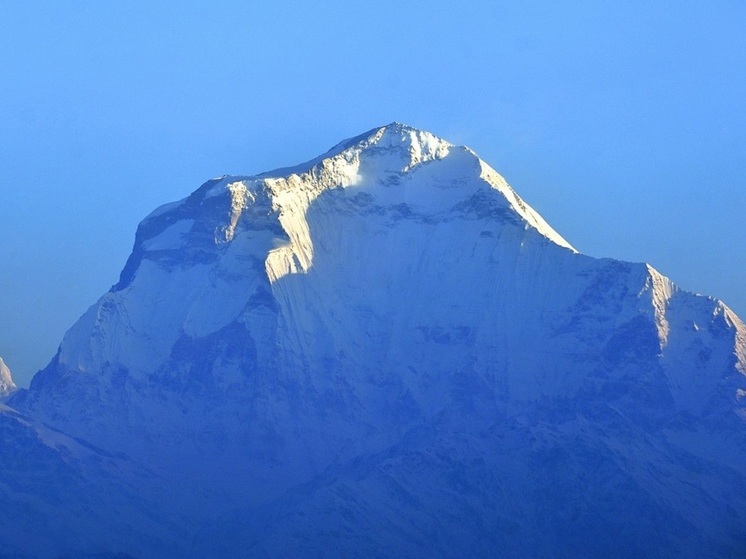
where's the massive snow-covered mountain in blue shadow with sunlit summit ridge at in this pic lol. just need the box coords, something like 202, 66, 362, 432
0, 124, 746, 557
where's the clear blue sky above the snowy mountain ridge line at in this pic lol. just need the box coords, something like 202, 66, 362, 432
0, 0, 746, 386
